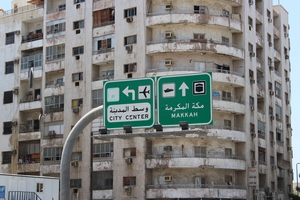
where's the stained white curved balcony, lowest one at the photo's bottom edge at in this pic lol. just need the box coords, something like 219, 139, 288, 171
146, 184, 247, 199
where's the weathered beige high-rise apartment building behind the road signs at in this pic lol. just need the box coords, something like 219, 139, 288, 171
0, 0, 293, 200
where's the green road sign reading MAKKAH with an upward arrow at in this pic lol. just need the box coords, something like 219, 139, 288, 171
157, 72, 213, 127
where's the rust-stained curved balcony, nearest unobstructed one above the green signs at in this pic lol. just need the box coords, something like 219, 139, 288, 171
146, 39, 244, 60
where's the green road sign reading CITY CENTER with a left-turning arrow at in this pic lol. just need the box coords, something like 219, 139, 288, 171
103, 78, 155, 130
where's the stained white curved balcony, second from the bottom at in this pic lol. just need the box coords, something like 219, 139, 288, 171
146, 154, 246, 170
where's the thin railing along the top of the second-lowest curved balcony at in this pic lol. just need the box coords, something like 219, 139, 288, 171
146, 153, 245, 160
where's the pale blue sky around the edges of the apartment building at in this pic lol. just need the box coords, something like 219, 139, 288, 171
0, 0, 300, 183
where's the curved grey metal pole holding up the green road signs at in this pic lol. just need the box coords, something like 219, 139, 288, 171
60, 106, 103, 200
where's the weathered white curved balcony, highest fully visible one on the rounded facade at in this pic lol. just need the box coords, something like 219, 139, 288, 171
146, 10, 243, 32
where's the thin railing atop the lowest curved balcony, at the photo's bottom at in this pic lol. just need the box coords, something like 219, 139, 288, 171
146, 184, 247, 190
